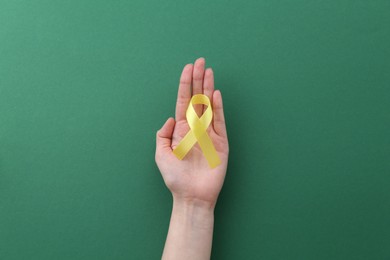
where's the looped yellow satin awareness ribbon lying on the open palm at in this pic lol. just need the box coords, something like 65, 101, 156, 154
173, 94, 221, 168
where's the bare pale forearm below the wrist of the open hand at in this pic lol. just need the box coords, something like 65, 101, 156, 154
162, 199, 214, 260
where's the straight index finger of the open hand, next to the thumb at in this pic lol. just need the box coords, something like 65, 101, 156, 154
175, 64, 194, 122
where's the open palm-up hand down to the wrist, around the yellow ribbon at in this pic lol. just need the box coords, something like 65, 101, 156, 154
155, 58, 229, 208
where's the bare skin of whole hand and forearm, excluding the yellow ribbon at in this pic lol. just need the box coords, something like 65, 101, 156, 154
155, 58, 229, 260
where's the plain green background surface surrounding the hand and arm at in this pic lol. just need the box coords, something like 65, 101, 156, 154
0, 0, 390, 260
